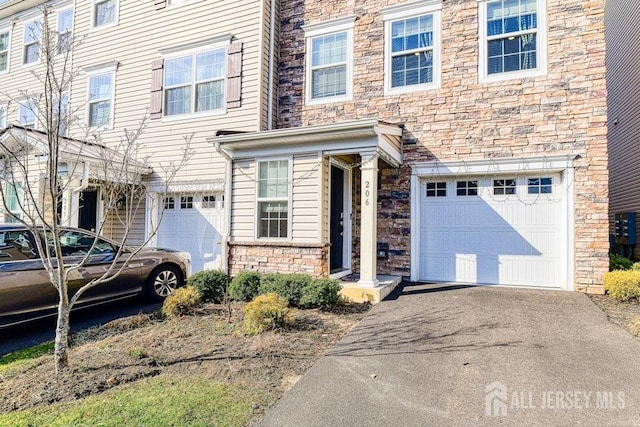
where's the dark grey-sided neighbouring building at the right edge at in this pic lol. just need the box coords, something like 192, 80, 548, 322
605, 0, 640, 260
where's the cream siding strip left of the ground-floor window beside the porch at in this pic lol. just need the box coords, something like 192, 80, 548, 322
231, 161, 256, 241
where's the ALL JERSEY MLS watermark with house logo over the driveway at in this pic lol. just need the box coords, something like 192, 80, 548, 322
484, 381, 626, 417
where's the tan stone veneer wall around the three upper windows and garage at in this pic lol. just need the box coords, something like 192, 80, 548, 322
278, 0, 609, 290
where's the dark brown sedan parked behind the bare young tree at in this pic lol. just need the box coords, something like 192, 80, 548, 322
0, 224, 191, 328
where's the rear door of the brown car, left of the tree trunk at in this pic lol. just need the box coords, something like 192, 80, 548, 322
0, 229, 58, 326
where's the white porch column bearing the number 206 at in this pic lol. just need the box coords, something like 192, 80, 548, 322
358, 153, 378, 288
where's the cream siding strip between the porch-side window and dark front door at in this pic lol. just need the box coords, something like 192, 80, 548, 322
291, 153, 322, 243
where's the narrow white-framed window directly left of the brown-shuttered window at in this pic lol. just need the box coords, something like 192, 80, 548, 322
87, 71, 115, 127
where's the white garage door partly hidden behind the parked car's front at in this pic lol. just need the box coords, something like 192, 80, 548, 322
157, 194, 224, 273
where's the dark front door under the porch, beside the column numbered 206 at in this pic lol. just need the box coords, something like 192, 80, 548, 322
329, 166, 345, 273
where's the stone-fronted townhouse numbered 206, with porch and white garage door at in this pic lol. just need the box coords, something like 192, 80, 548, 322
211, 0, 608, 293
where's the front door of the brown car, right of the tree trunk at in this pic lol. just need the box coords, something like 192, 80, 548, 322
55, 230, 141, 303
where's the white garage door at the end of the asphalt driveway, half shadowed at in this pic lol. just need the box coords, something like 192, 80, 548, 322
419, 174, 566, 288
